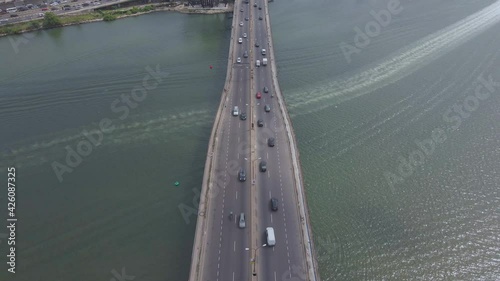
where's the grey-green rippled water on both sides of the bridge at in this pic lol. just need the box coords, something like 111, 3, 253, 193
0, 0, 500, 280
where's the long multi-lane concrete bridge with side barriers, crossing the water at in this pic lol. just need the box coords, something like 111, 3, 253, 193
189, 0, 320, 281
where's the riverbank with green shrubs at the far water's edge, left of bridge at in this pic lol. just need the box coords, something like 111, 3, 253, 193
0, 3, 233, 37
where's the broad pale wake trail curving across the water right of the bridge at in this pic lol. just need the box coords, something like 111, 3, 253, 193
288, 1, 500, 116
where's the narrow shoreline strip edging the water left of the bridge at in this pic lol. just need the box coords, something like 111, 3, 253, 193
0, 3, 234, 37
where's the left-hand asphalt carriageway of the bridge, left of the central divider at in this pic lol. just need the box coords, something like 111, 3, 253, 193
202, 0, 252, 280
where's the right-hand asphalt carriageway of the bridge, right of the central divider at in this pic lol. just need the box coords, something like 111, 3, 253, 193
252, 0, 306, 281
